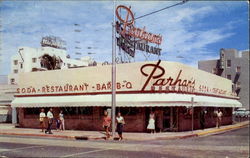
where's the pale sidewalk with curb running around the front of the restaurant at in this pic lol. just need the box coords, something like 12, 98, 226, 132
0, 121, 249, 141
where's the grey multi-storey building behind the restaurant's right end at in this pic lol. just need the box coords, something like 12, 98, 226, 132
198, 49, 249, 109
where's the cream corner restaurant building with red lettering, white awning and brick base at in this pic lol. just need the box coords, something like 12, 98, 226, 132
11, 60, 241, 132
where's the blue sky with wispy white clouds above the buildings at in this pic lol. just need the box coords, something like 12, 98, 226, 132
0, 0, 249, 75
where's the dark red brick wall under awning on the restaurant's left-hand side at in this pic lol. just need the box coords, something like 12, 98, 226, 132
19, 107, 146, 132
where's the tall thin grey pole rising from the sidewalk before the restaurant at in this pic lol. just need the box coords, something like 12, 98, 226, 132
111, 1, 116, 138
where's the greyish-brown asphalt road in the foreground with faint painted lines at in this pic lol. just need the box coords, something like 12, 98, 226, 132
0, 127, 249, 158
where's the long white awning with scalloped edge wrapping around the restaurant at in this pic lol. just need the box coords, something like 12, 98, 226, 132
11, 93, 242, 107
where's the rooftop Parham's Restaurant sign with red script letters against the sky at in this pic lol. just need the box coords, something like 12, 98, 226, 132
116, 5, 162, 57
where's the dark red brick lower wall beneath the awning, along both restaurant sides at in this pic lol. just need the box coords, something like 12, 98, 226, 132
19, 107, 232, 132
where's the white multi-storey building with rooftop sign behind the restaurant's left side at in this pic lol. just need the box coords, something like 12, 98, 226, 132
8, 36, 96, 84
